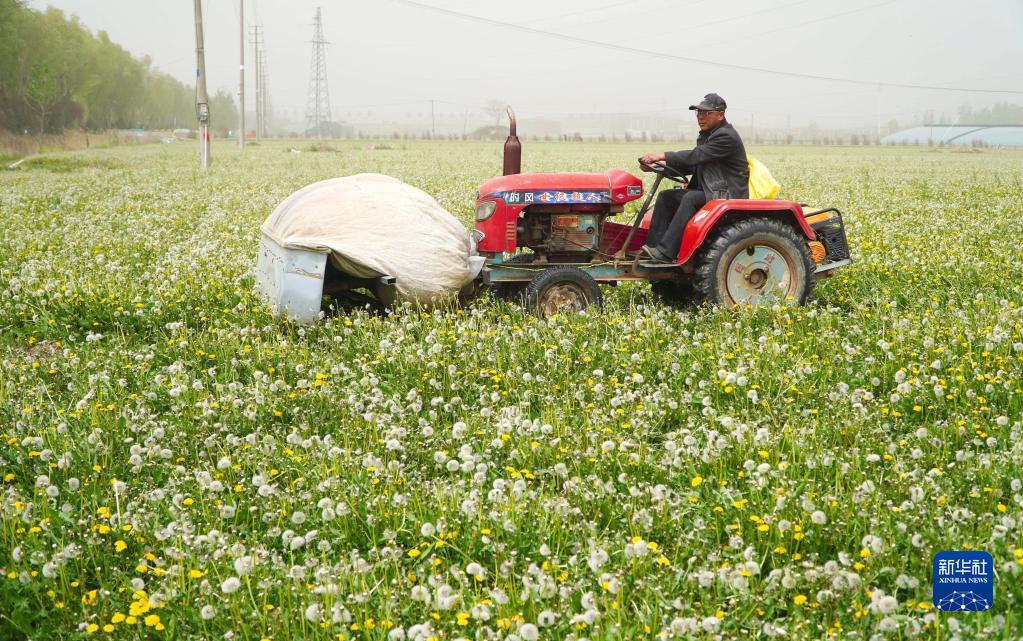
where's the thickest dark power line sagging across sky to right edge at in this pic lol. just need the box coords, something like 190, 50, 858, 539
391, 0, 1023, 95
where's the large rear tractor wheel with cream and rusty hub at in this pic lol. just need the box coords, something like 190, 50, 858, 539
696, 218, 815, 307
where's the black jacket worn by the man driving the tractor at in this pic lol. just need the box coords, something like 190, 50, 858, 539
665, 121, 750, 200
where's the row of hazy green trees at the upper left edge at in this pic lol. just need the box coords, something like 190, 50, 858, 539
0, 0, 238, 134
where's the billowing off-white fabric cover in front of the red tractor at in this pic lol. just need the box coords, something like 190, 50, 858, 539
262, 174, 483, 305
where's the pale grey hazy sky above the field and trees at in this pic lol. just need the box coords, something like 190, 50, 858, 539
30, 0, 1023, 133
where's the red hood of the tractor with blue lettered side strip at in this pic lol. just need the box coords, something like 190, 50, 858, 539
478, 169, 642, 204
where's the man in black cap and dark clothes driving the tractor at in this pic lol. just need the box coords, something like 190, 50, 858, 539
639, 93, 750, 263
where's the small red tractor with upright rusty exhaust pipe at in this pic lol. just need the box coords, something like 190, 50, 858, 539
476, 108, 850, 316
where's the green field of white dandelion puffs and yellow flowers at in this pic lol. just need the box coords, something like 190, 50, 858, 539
0, 141, 1023, 641
